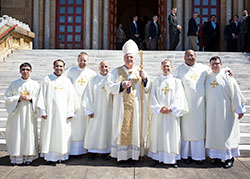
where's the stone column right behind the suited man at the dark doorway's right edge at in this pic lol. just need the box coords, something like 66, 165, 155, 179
176, 0, 185, 50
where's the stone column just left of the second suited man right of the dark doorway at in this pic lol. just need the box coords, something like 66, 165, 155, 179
185, 0, 192, 50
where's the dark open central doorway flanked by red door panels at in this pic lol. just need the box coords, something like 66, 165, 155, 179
109, 0, 166, 49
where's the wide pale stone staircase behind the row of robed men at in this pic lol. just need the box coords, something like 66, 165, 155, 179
0, 50, 250, 157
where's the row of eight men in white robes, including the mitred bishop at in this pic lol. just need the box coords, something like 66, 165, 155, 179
5, 40, 245, 168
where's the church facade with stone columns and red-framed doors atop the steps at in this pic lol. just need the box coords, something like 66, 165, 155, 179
0, 0, 250, 51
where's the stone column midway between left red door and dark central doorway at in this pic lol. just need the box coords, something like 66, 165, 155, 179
92, 0, 100, 49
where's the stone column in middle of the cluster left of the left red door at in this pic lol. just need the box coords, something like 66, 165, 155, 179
44, 0, 50, 49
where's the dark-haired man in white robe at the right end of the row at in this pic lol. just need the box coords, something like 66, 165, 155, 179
206, 56, 246, 168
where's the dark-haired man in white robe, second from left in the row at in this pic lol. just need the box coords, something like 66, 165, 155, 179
37, 59, 76, 162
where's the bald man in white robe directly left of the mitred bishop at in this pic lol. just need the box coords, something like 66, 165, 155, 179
82, 61, 113, 158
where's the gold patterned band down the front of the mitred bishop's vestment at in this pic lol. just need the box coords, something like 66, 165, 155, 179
118, 67, 140, 146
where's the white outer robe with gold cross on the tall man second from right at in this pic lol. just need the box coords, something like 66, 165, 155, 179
175, 63, 210, 141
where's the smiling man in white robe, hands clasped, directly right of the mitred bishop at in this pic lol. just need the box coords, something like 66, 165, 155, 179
148, 59, 188, 168
